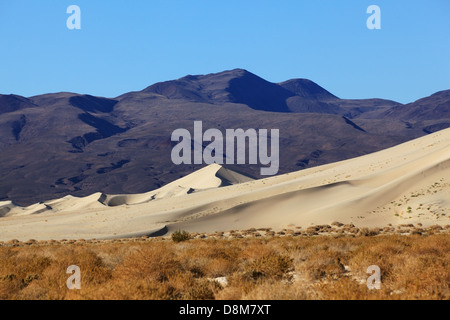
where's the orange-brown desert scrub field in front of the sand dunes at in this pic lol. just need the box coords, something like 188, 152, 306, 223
0, 234, 450, 300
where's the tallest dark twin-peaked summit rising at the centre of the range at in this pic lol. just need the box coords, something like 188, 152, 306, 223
144, 69, 338, 113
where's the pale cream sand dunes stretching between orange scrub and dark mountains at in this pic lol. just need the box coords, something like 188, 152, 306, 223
0, 129, 450, 240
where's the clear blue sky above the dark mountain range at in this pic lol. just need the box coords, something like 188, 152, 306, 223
0, 0, 450, 103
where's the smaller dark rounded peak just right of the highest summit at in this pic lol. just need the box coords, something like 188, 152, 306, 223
279, 79, 339, 101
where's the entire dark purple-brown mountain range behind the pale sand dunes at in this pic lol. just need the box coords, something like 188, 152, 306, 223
0, 69, 450, 206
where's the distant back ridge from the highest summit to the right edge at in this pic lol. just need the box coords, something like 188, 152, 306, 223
137, 68, 450, 120
